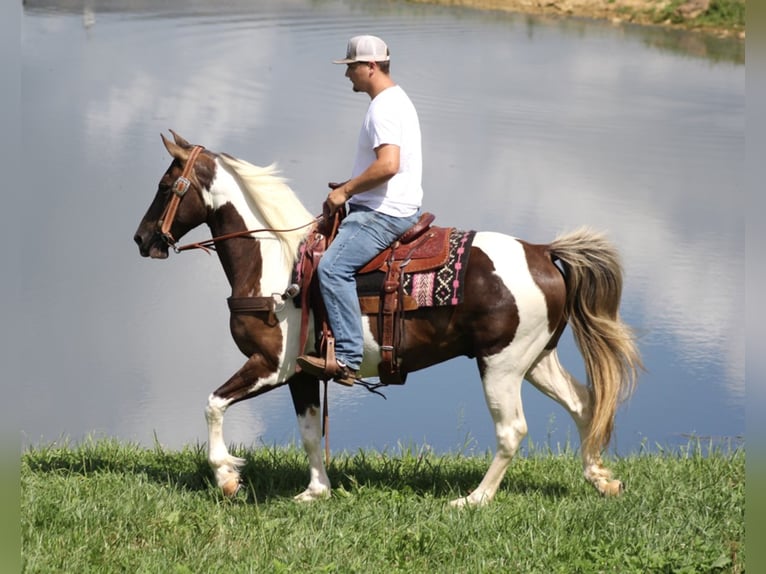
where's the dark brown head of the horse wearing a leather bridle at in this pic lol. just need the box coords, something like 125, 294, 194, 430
133, 130, 215, 259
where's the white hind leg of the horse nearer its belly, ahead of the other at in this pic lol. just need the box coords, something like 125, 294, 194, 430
450, 356, 527, 507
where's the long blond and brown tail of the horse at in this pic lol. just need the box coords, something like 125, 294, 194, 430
548, 227, 643, 452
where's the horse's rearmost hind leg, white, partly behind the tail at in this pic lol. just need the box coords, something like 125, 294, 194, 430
526, 349, 624, 496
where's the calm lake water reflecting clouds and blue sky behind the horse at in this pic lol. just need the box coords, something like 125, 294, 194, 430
21, 0, 745, 460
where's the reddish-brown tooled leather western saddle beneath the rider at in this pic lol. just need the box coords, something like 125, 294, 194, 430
297, 210, 452, 385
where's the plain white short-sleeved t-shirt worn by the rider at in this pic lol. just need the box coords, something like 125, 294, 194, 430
349, 86, 423, 217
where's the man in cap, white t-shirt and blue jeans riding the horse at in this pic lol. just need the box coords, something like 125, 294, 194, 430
298, 36, 423, 386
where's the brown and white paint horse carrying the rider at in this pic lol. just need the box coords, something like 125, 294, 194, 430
134, 132, 641, 506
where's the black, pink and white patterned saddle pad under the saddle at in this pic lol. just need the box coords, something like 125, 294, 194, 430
356, 229, 476, 307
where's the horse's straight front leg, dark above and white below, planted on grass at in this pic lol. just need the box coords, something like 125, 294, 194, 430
289, 373, 330, 502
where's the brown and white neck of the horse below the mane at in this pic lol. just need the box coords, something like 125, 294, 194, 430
208, 161, 306, 297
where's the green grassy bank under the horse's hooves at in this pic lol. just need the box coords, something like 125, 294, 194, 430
21, 441, 745, 573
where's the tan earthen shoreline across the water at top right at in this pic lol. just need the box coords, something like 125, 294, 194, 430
408, 0, 745, 41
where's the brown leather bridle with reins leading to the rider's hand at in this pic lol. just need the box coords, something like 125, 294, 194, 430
157, 145, 324, 253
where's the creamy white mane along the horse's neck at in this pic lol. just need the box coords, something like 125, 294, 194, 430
219, 154, 314, 265
